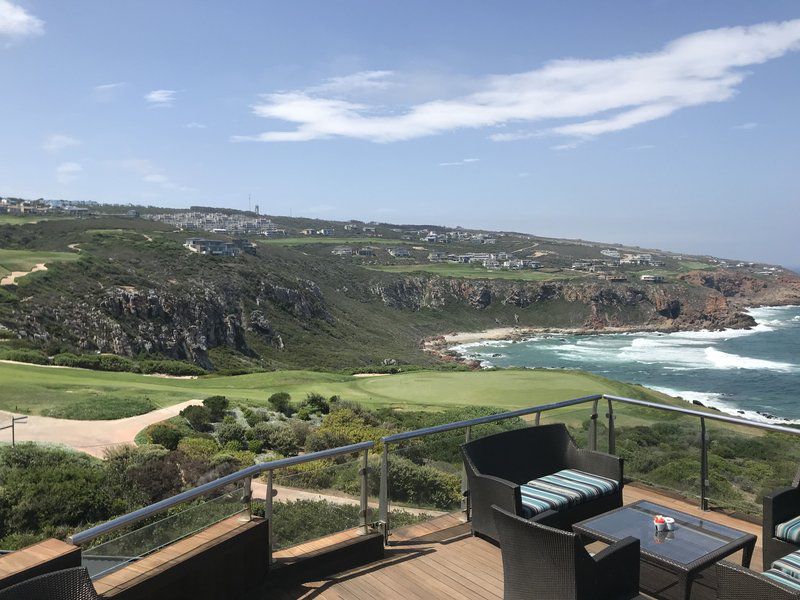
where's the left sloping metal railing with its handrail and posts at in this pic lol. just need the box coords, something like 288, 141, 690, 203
67, 442, 375, 559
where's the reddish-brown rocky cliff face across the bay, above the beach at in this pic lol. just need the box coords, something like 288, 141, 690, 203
370, 276, 755, 329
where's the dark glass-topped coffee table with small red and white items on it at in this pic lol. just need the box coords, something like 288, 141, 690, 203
573, 500, 756, 598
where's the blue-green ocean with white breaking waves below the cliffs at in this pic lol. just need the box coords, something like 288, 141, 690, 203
454, 306, 800, 424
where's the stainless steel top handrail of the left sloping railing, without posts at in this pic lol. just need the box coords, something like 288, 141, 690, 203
67, 441, 375, 546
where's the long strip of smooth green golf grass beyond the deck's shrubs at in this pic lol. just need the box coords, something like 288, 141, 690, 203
0, 363, 666, 419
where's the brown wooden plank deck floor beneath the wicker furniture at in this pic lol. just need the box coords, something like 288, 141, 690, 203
263, 486, 761, 600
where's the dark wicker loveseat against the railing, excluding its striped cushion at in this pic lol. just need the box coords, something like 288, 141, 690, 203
461, 423, 622, 540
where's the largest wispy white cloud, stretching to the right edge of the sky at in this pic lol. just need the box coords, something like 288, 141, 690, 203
232, 19, 800, 148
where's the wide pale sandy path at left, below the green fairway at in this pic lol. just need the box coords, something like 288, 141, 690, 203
0, 400, 200, 458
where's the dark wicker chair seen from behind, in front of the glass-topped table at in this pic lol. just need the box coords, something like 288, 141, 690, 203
492, 506, 643, 600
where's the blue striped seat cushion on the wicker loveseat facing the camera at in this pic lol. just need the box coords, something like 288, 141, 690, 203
520, 469, 619, 518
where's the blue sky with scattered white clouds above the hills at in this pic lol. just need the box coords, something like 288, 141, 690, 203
0, 0, 800, 265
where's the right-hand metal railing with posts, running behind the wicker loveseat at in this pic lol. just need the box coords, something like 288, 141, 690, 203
378, 394, 800, 540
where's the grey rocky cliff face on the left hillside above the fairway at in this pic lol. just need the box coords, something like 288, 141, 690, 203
17, 280, 333, 368
